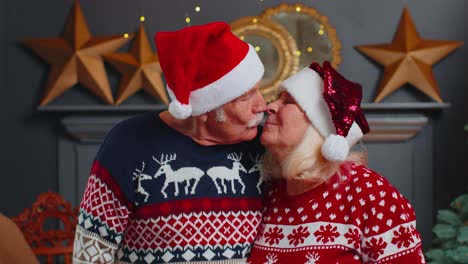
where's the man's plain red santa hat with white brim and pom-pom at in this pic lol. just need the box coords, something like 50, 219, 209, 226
155, 22, 264, 119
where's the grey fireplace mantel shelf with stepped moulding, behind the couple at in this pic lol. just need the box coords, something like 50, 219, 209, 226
38, 103, 450, 143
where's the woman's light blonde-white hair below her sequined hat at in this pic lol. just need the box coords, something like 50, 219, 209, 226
261, 125, 367, 182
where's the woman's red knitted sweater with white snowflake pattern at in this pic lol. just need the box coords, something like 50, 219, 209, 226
247, 164, 425, 264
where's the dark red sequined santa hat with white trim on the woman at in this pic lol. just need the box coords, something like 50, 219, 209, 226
281, 61, 369, 162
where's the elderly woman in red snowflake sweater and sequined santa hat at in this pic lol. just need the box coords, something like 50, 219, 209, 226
248, 62, 425, 264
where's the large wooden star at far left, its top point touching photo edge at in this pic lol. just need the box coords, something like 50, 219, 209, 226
24, 0, 129, 106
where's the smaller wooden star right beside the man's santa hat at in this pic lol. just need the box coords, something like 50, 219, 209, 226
104, 25, 169, 105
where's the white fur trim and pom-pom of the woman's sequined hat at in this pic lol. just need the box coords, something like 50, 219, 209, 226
281, 68, 363, 161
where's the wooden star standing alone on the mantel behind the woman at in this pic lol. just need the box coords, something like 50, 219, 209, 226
355, 8, 462, 103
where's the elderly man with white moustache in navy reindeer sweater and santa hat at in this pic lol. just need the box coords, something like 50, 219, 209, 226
73, 22, 266, 263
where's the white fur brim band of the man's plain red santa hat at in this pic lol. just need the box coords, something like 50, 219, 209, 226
167, 44, 265, 116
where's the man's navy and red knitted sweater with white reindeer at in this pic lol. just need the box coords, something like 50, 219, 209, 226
73, 113, 263, 263
